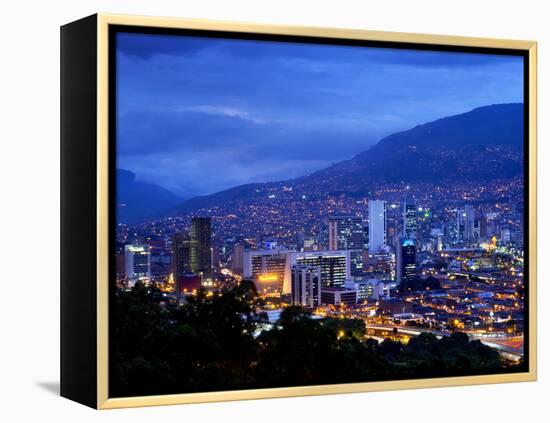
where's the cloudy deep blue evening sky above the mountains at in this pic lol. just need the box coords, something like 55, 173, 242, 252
117, 34, 523, 197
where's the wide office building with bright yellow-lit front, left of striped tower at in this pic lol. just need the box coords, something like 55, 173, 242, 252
243, 250, 290, 294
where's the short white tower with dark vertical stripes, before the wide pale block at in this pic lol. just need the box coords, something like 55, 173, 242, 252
291, 265, 321, 308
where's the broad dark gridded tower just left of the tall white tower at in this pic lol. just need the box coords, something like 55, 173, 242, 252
328, 216, 364, 275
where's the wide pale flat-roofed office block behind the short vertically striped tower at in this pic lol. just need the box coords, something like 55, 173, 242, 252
291, 250, 351, 288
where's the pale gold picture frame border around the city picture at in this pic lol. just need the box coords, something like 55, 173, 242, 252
62, 14, 537, 409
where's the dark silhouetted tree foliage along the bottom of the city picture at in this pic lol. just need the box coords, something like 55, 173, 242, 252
110, 281, 520, 397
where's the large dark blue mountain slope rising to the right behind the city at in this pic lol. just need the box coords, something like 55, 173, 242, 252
168, 103, 524, 215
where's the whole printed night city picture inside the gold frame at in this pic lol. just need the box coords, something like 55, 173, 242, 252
111, 30, 526, 396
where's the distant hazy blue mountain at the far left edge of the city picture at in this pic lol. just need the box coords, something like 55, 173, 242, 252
116, 169, 183, 224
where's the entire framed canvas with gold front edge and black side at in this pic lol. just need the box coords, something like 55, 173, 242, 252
61, 14, 537, 408
